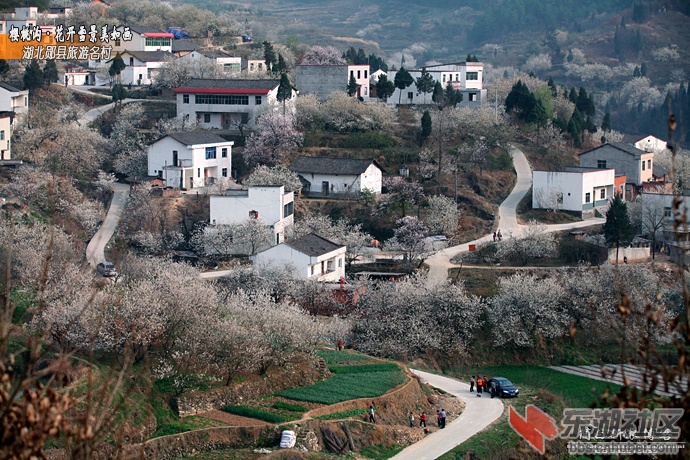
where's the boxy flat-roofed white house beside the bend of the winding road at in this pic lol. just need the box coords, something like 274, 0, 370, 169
532, 167, 616, 212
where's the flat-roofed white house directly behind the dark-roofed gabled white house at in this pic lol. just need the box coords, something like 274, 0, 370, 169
210, 185, 295, 244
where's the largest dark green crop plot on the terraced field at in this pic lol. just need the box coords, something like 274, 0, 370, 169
276, 369, 405, 404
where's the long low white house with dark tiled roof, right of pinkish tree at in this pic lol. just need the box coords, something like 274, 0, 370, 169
288, 155, 384, 195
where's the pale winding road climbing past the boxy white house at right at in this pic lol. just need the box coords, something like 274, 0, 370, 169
424, 146, 605, 284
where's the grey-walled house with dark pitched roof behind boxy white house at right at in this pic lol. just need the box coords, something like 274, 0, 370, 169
579, 142, 654, 201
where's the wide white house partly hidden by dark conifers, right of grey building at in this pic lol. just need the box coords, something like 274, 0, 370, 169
387, 62, 486, 107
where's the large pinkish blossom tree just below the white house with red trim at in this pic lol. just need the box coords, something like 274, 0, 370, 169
242, 113, 304, 166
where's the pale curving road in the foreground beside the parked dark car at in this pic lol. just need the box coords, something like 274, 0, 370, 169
392, 369, 503, 460
